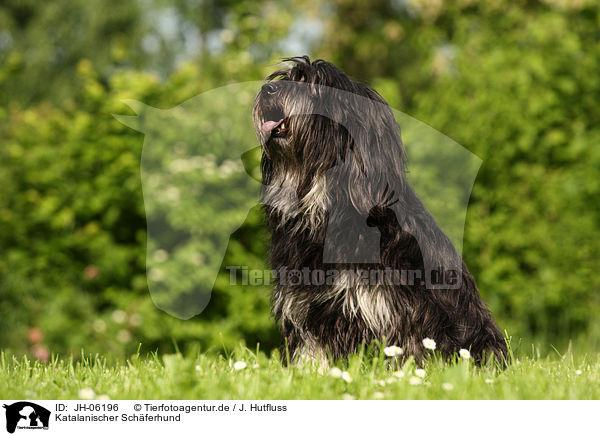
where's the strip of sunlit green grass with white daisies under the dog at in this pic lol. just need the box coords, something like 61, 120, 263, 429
0, 347, 600, 399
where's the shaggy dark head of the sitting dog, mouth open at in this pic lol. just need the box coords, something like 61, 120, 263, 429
253, 56, 404, 216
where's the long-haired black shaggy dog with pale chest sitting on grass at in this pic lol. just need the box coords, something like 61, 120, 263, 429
253, 56, 506, 361
